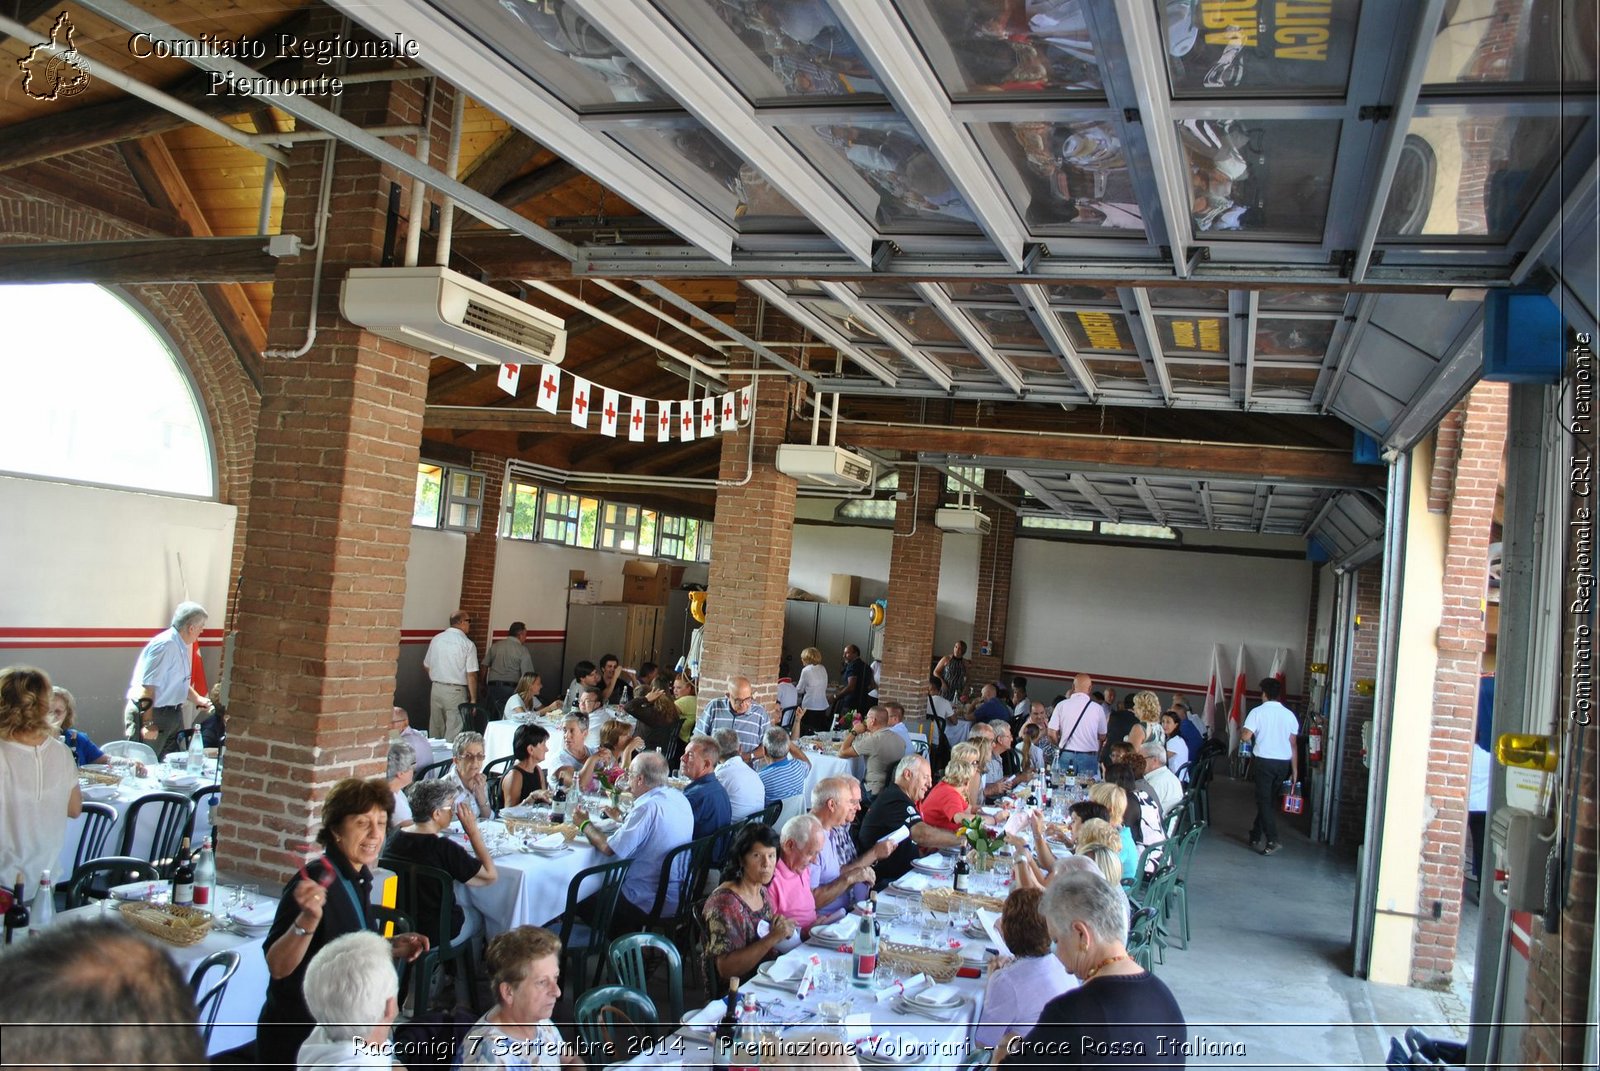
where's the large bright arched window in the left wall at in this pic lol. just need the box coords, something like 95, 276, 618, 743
0, 283, 216, 498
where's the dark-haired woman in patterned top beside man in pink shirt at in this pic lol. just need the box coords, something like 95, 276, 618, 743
704, 823, 795, 989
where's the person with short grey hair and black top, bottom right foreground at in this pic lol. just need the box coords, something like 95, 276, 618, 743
994, 868, 1187, 1068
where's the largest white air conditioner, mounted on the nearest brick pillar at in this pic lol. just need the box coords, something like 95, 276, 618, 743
339, 267, 566, 368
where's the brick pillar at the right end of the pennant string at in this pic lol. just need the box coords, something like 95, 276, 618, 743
699, 371, 795, 709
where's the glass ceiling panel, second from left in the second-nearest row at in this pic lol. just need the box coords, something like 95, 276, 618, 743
784, 118, 978, 234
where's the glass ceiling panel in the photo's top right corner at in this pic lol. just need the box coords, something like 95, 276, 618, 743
1422, 0, 1595, 91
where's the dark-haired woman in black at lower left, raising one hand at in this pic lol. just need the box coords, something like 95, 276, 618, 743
256, 778, 427, 1068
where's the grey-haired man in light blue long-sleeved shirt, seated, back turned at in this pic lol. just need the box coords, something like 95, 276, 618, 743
573, 751, 694, 933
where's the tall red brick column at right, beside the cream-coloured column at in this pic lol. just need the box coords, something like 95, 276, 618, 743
1411, 383, 1509, 985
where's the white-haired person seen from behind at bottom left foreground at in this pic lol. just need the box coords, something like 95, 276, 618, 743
298, 930, 402, 1071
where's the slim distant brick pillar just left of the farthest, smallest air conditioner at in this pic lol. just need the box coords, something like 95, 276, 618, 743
878, 464, 940, 711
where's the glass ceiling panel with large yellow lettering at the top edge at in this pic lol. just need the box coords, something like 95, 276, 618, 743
1155, 0, 1362, 98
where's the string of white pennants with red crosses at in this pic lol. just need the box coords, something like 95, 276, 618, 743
499, 365, 754, 442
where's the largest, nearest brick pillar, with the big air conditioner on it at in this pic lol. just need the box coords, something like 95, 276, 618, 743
218, 60, 450, 880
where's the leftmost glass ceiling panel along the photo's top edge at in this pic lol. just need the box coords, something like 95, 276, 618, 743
457, 0, 672, 110
